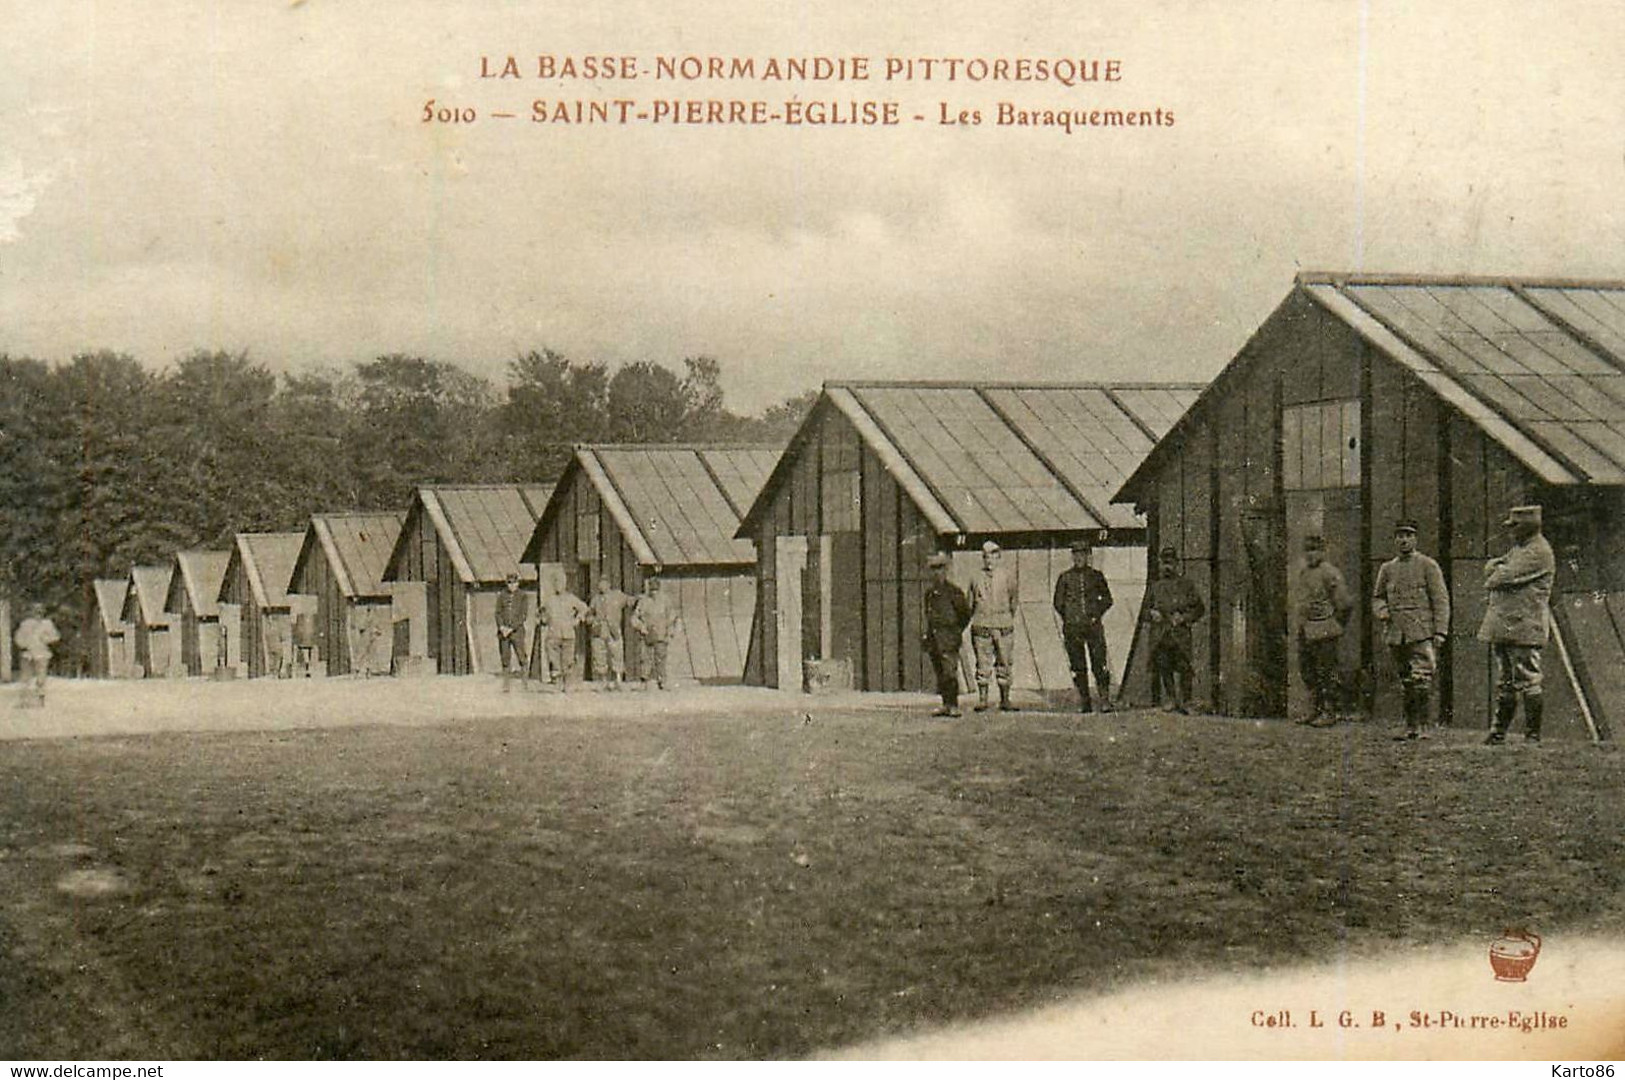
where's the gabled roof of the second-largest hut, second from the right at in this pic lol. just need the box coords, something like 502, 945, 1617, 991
739, 382, 1201, 536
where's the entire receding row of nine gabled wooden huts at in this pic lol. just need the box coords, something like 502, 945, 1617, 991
69, 274, 1625, 732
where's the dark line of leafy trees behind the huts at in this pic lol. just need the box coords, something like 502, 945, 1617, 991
0, 349, 816, 667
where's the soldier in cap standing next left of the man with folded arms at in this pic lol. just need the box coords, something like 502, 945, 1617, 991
1372, 518, 1450, 742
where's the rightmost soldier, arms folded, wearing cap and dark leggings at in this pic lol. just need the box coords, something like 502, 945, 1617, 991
1479, 505, 1557, 745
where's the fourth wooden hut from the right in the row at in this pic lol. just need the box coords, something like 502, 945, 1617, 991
384, 484, 553, 676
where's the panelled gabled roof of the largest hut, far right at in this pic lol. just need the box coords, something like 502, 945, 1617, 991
1116, 273, 1625, 502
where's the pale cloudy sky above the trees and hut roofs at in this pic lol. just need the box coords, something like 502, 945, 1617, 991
0, 0, 1625, 411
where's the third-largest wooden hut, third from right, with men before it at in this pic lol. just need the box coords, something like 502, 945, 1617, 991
522, 445, 780, 682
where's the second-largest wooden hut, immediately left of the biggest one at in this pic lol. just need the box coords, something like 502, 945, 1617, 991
739, 382, 1199, 692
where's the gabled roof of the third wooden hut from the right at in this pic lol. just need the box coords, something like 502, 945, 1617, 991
520, 443, 780, 567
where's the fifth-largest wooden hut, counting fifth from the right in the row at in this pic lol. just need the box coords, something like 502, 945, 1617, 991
288, 510, 406, 676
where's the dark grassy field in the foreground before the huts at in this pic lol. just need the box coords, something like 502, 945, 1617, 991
0, 697, 1625, 1059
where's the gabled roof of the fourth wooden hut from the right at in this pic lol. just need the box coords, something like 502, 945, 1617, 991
384, 484, 553, 585
